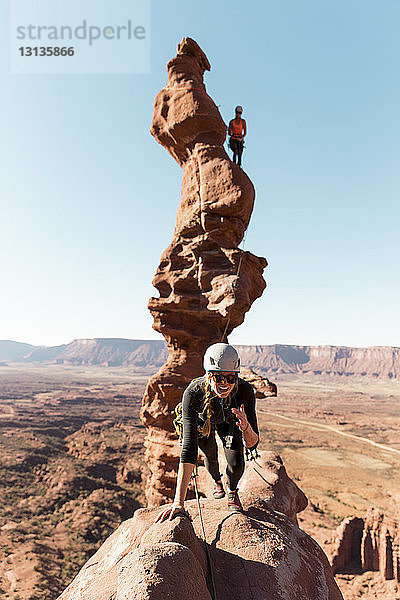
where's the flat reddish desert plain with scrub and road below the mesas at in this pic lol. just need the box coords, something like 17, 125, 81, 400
0, 364, 400, 600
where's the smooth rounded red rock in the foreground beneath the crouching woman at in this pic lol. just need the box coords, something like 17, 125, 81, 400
59, 454, 343, 600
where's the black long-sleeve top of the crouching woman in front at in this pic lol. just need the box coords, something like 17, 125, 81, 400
181, 375, 258, 464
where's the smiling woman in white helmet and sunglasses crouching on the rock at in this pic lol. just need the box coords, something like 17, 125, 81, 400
156, 343, 259, 522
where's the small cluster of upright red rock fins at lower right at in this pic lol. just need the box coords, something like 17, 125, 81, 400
332, 508, 400, 591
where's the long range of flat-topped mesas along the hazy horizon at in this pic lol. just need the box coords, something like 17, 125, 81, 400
0, 338, 400, 379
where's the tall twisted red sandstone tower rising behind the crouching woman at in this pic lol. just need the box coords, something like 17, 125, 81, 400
141, 38, 267, 505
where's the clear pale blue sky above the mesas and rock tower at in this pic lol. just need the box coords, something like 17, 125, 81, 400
0, 0, 400, 346
